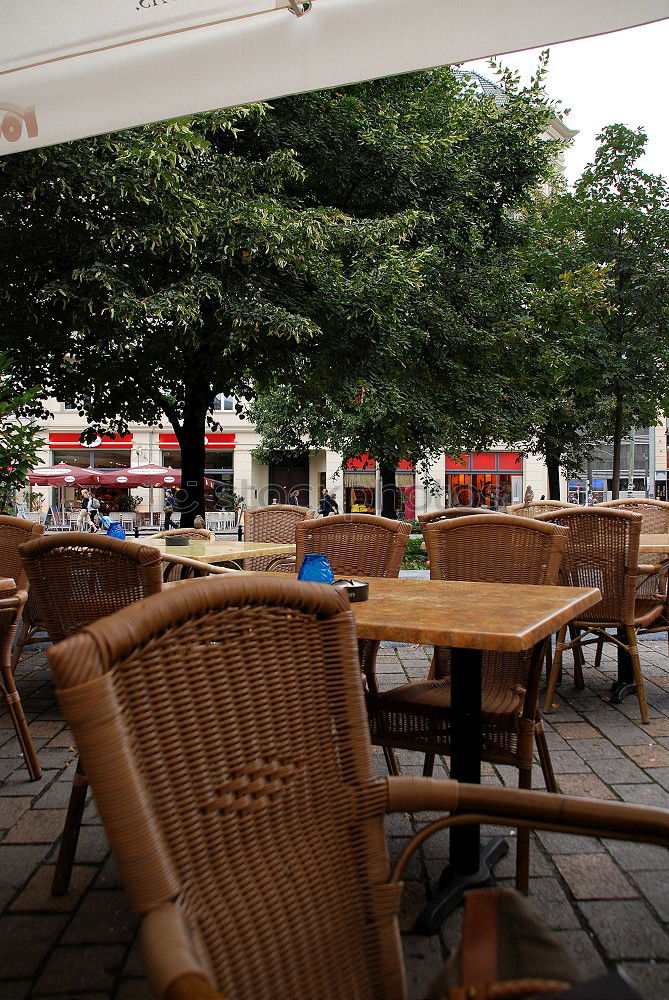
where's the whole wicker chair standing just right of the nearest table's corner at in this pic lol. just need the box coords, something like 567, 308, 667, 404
541, 504, 665, 724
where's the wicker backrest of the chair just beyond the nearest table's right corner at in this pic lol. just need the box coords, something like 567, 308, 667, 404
541, 504, 641, 625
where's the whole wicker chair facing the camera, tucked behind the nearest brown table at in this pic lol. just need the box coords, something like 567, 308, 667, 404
365, 514, 567, 892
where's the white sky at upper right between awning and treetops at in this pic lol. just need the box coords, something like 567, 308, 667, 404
465, 20, 669, 183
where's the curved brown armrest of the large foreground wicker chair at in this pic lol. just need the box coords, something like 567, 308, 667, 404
385, 777, 669, 881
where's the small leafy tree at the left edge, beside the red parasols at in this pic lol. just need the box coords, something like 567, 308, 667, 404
0, 354, 43, 514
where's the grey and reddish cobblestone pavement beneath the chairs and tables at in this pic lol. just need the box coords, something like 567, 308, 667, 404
0, 641, 669, 1000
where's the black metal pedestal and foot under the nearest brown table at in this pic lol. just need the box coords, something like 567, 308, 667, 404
413, 649, 509, 934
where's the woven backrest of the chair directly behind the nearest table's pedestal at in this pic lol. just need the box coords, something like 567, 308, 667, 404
425, 514, 567, 720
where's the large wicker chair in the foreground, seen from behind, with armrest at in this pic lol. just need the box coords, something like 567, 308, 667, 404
49, 574, 669, 1000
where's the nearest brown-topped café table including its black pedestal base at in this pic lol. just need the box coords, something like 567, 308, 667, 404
351, 579, 601, 933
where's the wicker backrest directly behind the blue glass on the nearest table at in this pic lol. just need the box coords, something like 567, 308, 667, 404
295, 514, 411, 577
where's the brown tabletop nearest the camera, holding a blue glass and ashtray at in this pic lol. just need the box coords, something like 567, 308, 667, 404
351, 578, 601, 653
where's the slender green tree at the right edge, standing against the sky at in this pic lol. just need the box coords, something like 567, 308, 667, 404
551, 125, 669, 498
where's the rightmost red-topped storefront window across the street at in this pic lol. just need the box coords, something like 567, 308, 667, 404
445, 451, 523, 510
